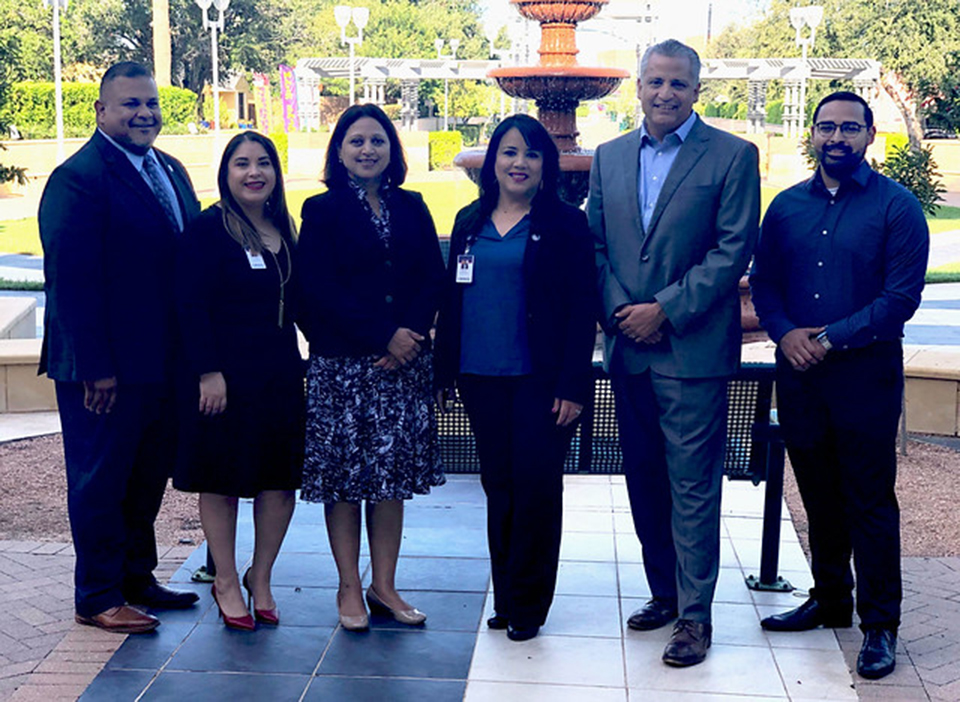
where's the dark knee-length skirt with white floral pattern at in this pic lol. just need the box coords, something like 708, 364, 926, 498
300, 352, 446, 504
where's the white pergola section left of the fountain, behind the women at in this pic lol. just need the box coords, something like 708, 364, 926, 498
296, 57, 502, 129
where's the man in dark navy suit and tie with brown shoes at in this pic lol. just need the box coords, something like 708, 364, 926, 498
40, 62, 200, 633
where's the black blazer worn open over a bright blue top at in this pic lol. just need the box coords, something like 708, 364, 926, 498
435, 200, 597, 404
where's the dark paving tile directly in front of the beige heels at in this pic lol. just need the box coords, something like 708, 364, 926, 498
318, 627, 476, 680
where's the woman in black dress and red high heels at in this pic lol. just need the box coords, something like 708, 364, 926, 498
174, 132, 304, 629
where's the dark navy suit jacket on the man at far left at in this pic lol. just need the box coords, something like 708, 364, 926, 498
40, 132, 200, 383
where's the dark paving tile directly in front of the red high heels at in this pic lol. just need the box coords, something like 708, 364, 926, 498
167, 624, 334, 675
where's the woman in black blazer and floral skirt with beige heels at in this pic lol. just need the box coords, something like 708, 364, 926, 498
296, 105, 444, 630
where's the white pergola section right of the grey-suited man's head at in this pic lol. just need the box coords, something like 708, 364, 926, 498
700, 58, 880, 134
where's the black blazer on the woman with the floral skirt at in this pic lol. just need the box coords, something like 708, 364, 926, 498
294, 187, 443, 357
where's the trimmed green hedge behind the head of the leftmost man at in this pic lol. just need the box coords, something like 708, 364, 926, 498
0, 81, 197, 139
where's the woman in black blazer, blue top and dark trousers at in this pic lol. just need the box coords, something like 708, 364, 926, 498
436, 115, 596, 641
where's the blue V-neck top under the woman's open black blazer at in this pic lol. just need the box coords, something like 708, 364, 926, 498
460, 215, 532, 376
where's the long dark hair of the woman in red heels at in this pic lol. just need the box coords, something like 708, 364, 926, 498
217, 131, 296, 253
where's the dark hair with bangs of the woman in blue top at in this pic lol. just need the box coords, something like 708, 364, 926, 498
480, 115, 560, 216
